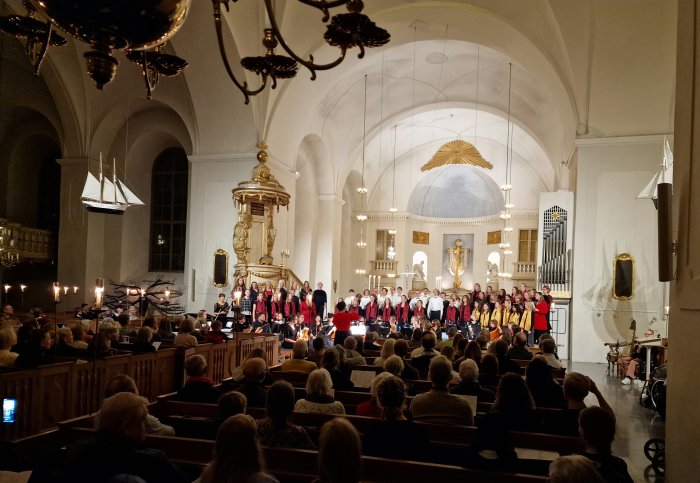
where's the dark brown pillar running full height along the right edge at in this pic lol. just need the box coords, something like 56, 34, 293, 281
666, 0, 700, 481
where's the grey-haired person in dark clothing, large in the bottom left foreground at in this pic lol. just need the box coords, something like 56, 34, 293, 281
63, 392, 191, 483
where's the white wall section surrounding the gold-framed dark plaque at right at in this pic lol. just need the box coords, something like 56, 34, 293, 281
570, 136, 663, 362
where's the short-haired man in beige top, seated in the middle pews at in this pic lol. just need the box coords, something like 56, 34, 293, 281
411, 356, 474, 426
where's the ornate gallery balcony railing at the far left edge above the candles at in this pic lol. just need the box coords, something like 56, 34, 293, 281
0, 218, 56, 260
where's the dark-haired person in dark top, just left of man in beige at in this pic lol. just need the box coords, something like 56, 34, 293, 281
364, 374, 428, 461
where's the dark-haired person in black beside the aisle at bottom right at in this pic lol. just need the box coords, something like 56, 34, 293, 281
579, 406, 632, 483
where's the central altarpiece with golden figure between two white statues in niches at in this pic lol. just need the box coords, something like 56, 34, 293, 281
436, 234, 474, 291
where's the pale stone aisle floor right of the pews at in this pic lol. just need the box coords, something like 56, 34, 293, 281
567, 362, 665, 482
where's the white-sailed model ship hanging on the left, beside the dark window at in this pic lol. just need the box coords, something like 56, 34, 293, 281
80, 153, 143, 215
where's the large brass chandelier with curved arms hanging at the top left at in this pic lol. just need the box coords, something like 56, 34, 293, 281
0, 0, 391, 104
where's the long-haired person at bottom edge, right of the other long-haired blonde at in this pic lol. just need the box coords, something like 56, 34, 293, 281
314, 418, 362, 483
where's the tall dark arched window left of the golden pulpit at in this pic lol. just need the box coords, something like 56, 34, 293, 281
149, 148, 188, 272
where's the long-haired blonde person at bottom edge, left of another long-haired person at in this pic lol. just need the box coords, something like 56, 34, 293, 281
195, 414, 277, 483
